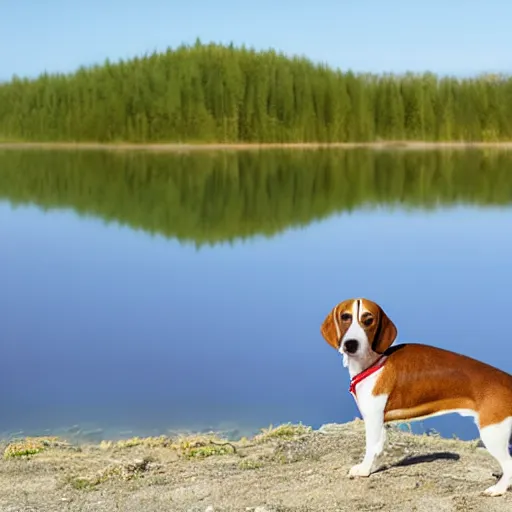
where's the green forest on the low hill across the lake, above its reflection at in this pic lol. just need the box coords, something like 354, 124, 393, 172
0, 40, 512, 143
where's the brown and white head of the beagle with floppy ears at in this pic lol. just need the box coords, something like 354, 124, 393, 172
320, 299, 397, 366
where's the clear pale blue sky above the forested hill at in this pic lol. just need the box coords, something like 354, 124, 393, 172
0, 0, 512, 80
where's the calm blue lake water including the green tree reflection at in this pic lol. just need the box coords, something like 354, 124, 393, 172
0, 147, 512, 438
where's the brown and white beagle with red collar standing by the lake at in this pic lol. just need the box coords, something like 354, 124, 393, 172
320, 298, 512, 496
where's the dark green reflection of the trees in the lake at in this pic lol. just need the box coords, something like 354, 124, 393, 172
0, 150, 512, 246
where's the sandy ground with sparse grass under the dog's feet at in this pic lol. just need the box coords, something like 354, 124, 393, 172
0, 420, 512, 512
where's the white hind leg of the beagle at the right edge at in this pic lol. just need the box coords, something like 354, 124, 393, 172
480, 416, 512, 496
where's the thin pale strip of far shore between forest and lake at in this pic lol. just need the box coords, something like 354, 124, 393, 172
0, 141, 512, 152
